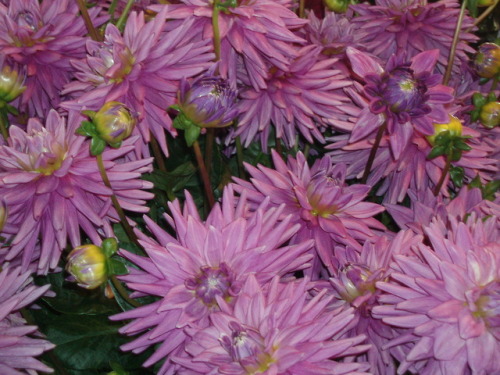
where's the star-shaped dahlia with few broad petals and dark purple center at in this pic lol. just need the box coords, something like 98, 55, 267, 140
347, 48, 453, 160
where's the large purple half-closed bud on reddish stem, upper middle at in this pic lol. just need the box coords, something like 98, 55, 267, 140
178, 76, 238, 128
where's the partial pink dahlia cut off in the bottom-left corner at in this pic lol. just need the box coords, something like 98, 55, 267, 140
0, 268, 54, 375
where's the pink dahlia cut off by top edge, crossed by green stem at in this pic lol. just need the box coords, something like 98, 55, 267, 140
151, 0, 307, 90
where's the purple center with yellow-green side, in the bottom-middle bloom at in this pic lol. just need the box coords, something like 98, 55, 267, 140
219, 322, 275, 375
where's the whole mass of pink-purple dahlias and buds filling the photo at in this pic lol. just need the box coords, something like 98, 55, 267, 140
0, 0, 500, 375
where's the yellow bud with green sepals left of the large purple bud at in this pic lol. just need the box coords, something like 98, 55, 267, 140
92, 102, 137, 147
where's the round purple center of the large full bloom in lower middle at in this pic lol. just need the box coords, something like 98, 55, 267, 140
185, 262, 235, 307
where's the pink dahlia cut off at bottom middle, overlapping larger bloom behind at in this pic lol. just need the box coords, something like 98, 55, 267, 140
172, 275, 368, 375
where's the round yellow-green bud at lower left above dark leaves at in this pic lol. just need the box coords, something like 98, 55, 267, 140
66, 245, 108, 289
